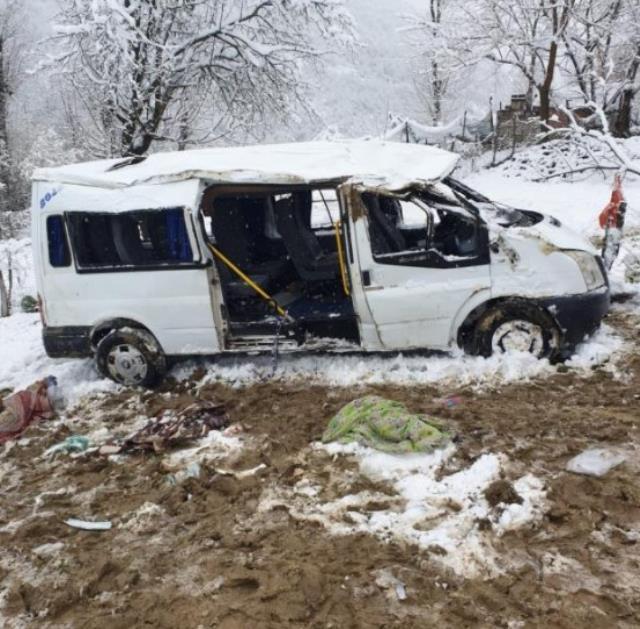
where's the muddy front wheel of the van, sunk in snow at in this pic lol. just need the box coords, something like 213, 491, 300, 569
471, 300, 560, 360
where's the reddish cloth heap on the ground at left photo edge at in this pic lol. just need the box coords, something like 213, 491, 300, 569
0, 377, 57, 444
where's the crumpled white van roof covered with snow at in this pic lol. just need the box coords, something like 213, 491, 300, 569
33, 140, 458, 189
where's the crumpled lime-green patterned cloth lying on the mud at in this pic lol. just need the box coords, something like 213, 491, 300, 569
322, 395, 452, 453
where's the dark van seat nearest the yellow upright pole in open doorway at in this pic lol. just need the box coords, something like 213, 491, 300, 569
274, 191, 339, 281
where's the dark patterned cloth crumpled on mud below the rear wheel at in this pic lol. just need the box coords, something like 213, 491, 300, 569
99, 401, 229, 455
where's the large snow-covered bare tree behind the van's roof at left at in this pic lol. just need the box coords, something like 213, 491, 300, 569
46, 0, 354, 155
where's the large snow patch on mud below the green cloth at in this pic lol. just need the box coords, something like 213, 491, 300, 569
258, 444, 546, 578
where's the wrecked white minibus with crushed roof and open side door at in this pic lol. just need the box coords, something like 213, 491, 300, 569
33, 141, 609, 385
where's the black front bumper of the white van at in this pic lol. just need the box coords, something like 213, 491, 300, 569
541, 287, 611, 354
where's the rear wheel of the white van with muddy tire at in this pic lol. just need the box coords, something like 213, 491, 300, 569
96, 328, 167, 387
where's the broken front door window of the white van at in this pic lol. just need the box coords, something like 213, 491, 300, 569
362, 193, 489, 268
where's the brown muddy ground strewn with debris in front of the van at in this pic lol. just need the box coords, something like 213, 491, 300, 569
0, 306, 640, 629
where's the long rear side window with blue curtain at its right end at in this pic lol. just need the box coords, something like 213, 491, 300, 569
68, 208, 194, 269
